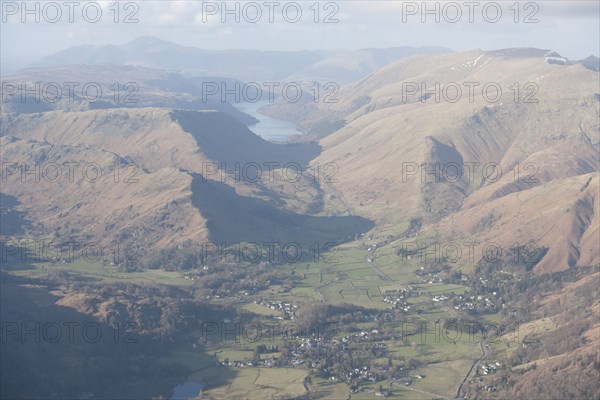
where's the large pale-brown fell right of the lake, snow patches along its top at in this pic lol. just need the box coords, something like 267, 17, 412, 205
308, 49, 600, 271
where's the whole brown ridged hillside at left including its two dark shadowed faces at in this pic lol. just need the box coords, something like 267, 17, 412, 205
0, 108, 370, 268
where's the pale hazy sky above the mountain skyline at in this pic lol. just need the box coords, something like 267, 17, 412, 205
0, 0, 600, 72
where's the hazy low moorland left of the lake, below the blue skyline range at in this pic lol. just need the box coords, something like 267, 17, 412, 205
0, 64, 257, 125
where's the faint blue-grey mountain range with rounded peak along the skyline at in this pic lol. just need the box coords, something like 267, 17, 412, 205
33, 37, 451, 84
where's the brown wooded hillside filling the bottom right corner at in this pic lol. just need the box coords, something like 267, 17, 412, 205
466, 270, 600, 399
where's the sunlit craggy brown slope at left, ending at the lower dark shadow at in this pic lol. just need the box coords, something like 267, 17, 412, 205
0, 136, 208, 249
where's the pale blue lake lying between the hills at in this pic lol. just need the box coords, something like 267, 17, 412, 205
234, 100, 301, 142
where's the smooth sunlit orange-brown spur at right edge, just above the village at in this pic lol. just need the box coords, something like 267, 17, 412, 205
431, 173, 600, 272
